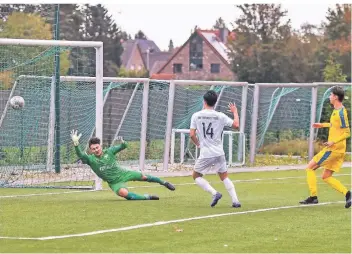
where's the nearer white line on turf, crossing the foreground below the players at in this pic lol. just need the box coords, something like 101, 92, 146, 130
0, 201, 344, 241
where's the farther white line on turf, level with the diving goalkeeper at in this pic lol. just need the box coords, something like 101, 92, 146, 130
0, 174, 351, 199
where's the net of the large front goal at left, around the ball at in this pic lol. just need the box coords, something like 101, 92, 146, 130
0, 39, 103, 189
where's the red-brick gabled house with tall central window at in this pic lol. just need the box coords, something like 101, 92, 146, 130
154, 28, 236, 80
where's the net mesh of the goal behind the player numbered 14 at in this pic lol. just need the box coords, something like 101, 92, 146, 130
171, 81, 246, 167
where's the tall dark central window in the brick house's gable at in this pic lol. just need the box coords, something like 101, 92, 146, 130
189, 35, 203, 71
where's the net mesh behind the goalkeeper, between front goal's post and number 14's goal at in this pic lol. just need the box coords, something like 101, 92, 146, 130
104, 81, 169, 170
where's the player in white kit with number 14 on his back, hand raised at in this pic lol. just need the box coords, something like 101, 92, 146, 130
190, 90, 241, 208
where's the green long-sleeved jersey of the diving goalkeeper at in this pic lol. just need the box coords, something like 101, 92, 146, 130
75, 143, 127, 183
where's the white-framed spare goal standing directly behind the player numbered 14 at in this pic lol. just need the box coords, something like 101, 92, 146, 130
163, 80, 248, 171
